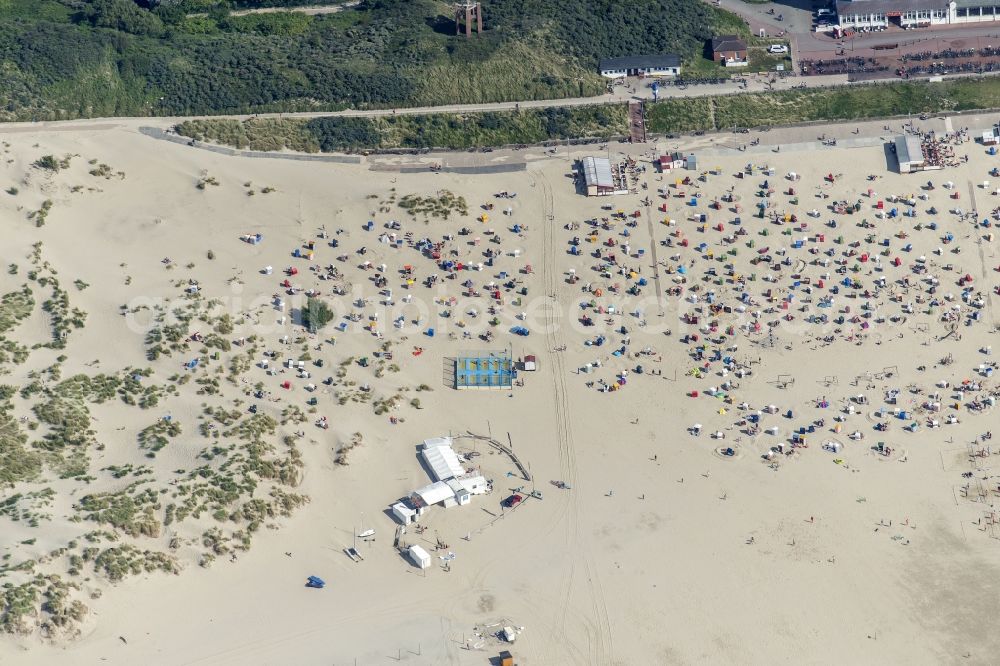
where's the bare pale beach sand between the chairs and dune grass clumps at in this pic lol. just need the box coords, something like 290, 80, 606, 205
0, 116, 1000, 665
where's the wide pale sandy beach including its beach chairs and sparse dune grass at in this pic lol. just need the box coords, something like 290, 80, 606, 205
0, 118, 1000, 665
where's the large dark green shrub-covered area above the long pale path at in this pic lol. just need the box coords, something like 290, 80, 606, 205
0, 0, 742, 120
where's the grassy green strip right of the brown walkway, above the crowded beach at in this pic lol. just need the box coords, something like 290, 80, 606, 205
647, 77, 1000, 133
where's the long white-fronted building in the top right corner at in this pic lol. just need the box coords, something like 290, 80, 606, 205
837, 0, 1000, 30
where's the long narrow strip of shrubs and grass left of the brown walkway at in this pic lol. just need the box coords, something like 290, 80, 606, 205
177, 105, 628, 152
